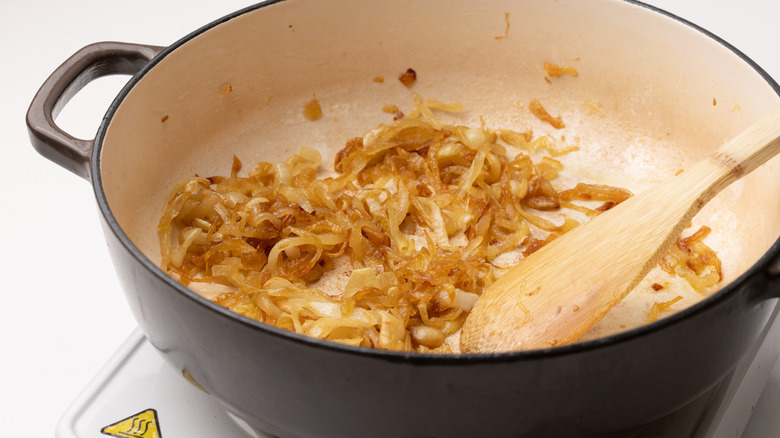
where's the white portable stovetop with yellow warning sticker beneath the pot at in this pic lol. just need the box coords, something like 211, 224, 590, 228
56, 304, 780, 438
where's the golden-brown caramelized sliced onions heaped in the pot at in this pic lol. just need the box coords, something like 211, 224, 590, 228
158, 97, 720, 352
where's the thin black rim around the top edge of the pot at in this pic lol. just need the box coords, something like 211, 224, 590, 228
90, 0, 780, 365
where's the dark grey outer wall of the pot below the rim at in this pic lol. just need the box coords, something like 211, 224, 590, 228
100, 214, 773, 437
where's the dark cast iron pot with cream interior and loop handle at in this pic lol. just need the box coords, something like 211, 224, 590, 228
27, 0, 780, 437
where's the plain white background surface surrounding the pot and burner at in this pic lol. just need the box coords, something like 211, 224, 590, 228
0, 0, 780, 438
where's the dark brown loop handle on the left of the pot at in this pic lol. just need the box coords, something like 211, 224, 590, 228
27, 42, 163, 180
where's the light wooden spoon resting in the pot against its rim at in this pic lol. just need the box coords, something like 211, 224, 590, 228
460, 107, 780, 353
